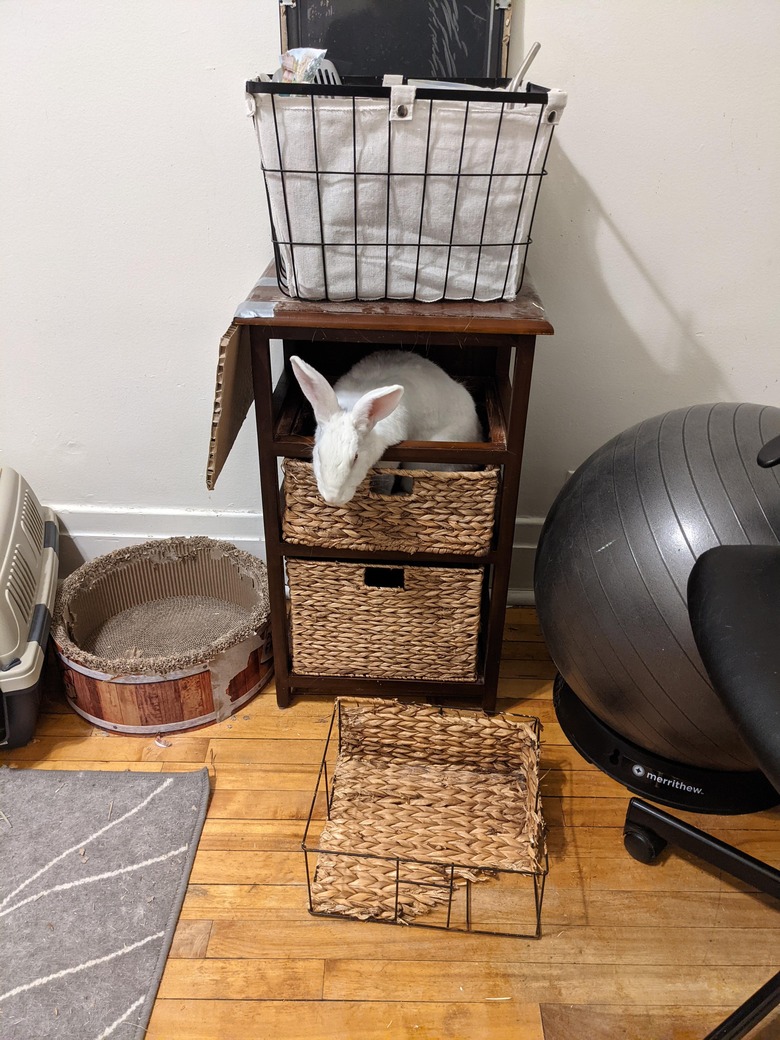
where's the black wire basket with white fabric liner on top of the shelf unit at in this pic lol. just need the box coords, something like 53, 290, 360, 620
246, 80, 566, 302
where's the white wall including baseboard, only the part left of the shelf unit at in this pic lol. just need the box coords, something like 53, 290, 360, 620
0, 0, 279, 569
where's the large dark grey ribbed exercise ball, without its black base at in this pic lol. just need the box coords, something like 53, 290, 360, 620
535, 404, 780, 771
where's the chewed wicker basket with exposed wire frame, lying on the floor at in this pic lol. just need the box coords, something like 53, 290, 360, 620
302, 699, 548, 938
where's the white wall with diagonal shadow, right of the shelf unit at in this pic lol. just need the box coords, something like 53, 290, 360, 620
511, 0, 780, 516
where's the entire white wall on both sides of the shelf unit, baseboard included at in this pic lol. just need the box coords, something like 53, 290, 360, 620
0, 0, 780, 584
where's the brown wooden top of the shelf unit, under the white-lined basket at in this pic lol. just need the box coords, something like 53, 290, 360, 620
234, 263, 553, 336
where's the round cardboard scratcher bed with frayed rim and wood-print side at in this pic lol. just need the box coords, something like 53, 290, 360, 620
52, 538, 272, 733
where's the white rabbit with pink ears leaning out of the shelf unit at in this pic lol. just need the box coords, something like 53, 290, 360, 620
290, 350, 483, 505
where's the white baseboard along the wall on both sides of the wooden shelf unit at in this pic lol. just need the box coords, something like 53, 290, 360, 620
52, 505, 544, 606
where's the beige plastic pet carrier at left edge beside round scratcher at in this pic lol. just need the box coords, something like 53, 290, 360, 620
0, 466, 59, 749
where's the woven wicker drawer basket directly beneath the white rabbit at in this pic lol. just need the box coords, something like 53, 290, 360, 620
283, 459, 498, 555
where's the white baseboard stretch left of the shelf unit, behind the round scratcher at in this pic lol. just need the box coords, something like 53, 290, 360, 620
52, 504, 264, 577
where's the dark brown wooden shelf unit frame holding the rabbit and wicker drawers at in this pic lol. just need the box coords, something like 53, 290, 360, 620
217, 268, 553, 710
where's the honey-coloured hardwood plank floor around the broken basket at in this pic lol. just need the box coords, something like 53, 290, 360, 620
7, 608, 780, 1040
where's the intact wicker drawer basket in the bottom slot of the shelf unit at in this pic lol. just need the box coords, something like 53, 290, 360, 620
287, 560, 484, 682
